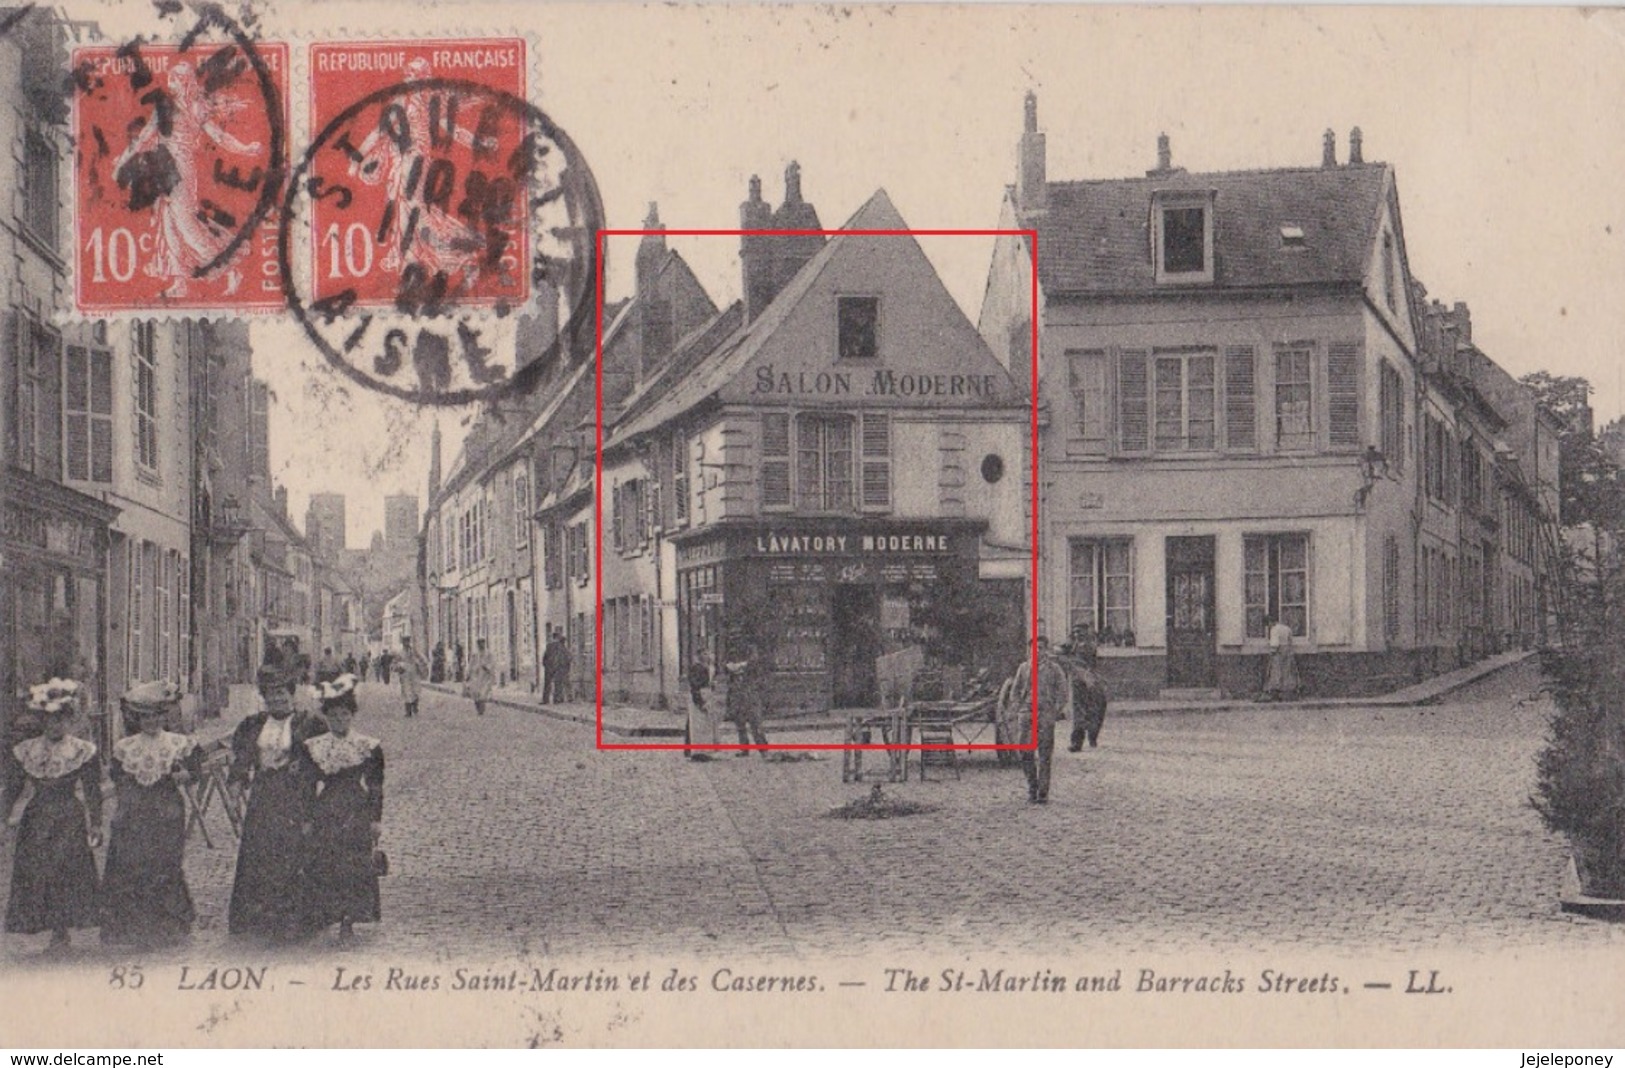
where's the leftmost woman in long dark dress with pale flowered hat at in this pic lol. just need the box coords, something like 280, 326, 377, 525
5, 679, 101, 954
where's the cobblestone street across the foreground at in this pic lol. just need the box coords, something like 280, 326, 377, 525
5, 656, 1619, 961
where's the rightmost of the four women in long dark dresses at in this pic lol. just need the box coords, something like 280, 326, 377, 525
306, 675, 384, 943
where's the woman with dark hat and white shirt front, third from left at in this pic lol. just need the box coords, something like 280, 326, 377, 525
226, 668, 322, 941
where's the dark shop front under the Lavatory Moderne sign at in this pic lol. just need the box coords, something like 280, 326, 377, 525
673, 519, 1001, 715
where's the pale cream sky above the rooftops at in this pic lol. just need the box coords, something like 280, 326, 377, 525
209, 2, 1625, 548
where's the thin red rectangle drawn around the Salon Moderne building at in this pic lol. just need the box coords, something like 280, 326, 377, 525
593, 229, 1040, 753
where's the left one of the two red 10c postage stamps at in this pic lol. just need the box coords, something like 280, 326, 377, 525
73, 33, 289, 314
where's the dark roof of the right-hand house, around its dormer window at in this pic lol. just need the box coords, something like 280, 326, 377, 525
1037, 163, 1389, 294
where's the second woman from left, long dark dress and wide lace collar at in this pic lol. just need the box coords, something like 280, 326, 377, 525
101, 683, 203, 949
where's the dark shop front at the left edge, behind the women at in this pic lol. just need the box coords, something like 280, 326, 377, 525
0, 468, 119, 753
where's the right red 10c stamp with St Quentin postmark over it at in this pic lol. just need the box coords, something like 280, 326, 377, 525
306, 37, 530, 310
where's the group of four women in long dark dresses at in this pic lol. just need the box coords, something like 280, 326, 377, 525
5, 668, 384, 953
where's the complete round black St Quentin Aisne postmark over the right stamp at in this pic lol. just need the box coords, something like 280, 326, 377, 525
276, 72, 603, 405
